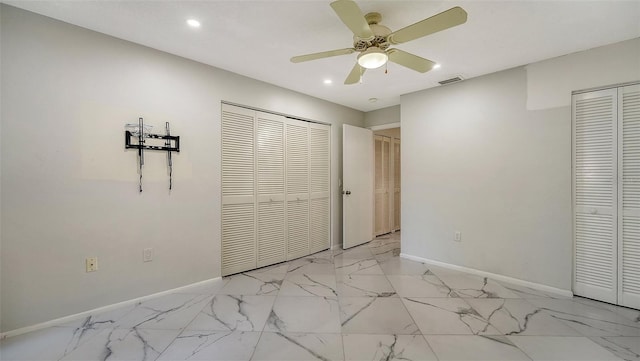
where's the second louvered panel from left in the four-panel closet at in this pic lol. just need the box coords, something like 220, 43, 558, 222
256, 112, 287, 267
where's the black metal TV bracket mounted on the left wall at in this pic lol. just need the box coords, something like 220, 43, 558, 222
124, 118, 180, 192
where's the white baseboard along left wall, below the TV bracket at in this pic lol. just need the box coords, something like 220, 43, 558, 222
0, 277, 221, 340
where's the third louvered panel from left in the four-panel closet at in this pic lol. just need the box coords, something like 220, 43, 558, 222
285, 119, 309, 259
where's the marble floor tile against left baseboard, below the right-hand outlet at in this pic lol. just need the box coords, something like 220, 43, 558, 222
117, 293, 212, 330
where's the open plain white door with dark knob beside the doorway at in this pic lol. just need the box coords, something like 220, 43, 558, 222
342, 124, 374, 249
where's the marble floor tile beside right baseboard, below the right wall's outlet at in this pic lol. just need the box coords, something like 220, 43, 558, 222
438, 274, 520, 298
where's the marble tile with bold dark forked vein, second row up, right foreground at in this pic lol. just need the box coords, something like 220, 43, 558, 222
465, 298, 581, 336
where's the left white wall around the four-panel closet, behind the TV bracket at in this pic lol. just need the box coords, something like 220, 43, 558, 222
0, 5, 364, 331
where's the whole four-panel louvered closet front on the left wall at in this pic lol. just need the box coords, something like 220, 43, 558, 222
221, 104, 330, 276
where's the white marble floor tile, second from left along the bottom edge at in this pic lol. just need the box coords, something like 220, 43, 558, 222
62, 328, 180, 361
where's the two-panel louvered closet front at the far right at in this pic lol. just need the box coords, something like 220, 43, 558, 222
572, 85, 640, 308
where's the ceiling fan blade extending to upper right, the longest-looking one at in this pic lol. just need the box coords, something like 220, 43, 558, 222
387, 6, 467, 44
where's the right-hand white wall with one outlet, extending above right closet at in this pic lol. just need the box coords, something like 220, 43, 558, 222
401, 40, 640, 290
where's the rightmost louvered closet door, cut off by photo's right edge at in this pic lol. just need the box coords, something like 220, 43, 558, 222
618, 85, 640, 308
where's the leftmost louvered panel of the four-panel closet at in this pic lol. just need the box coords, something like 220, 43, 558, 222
222, 104, 256, 275
